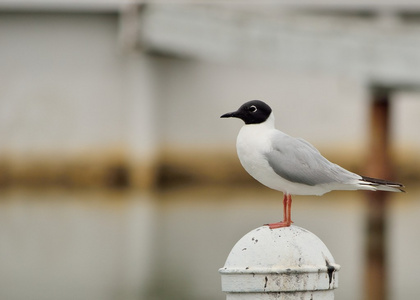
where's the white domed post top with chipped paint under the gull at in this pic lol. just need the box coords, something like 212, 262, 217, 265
219, 226, 340, 300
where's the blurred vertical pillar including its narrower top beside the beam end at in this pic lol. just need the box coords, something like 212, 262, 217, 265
119, 3, 159, 189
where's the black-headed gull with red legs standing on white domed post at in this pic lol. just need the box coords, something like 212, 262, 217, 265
221, 100, 404, 229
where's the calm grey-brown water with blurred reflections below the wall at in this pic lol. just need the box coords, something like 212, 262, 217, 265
0, 187, 420, 300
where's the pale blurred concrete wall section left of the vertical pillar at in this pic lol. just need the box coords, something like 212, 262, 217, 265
0, 13, 127, 154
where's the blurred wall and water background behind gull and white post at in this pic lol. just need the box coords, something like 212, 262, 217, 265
0, 0, 420, 300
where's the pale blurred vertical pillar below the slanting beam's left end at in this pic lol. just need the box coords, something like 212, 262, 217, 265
124, 52, 159, 189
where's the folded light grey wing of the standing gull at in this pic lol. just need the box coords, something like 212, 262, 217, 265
266, 134, 360, 186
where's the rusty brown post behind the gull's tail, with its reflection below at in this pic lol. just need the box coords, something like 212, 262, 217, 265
365, 88, 391, 300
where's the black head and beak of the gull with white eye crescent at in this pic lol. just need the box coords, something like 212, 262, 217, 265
221, 100, 271, 124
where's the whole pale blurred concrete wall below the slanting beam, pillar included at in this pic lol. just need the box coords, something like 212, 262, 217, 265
0, 10, 420, 185
